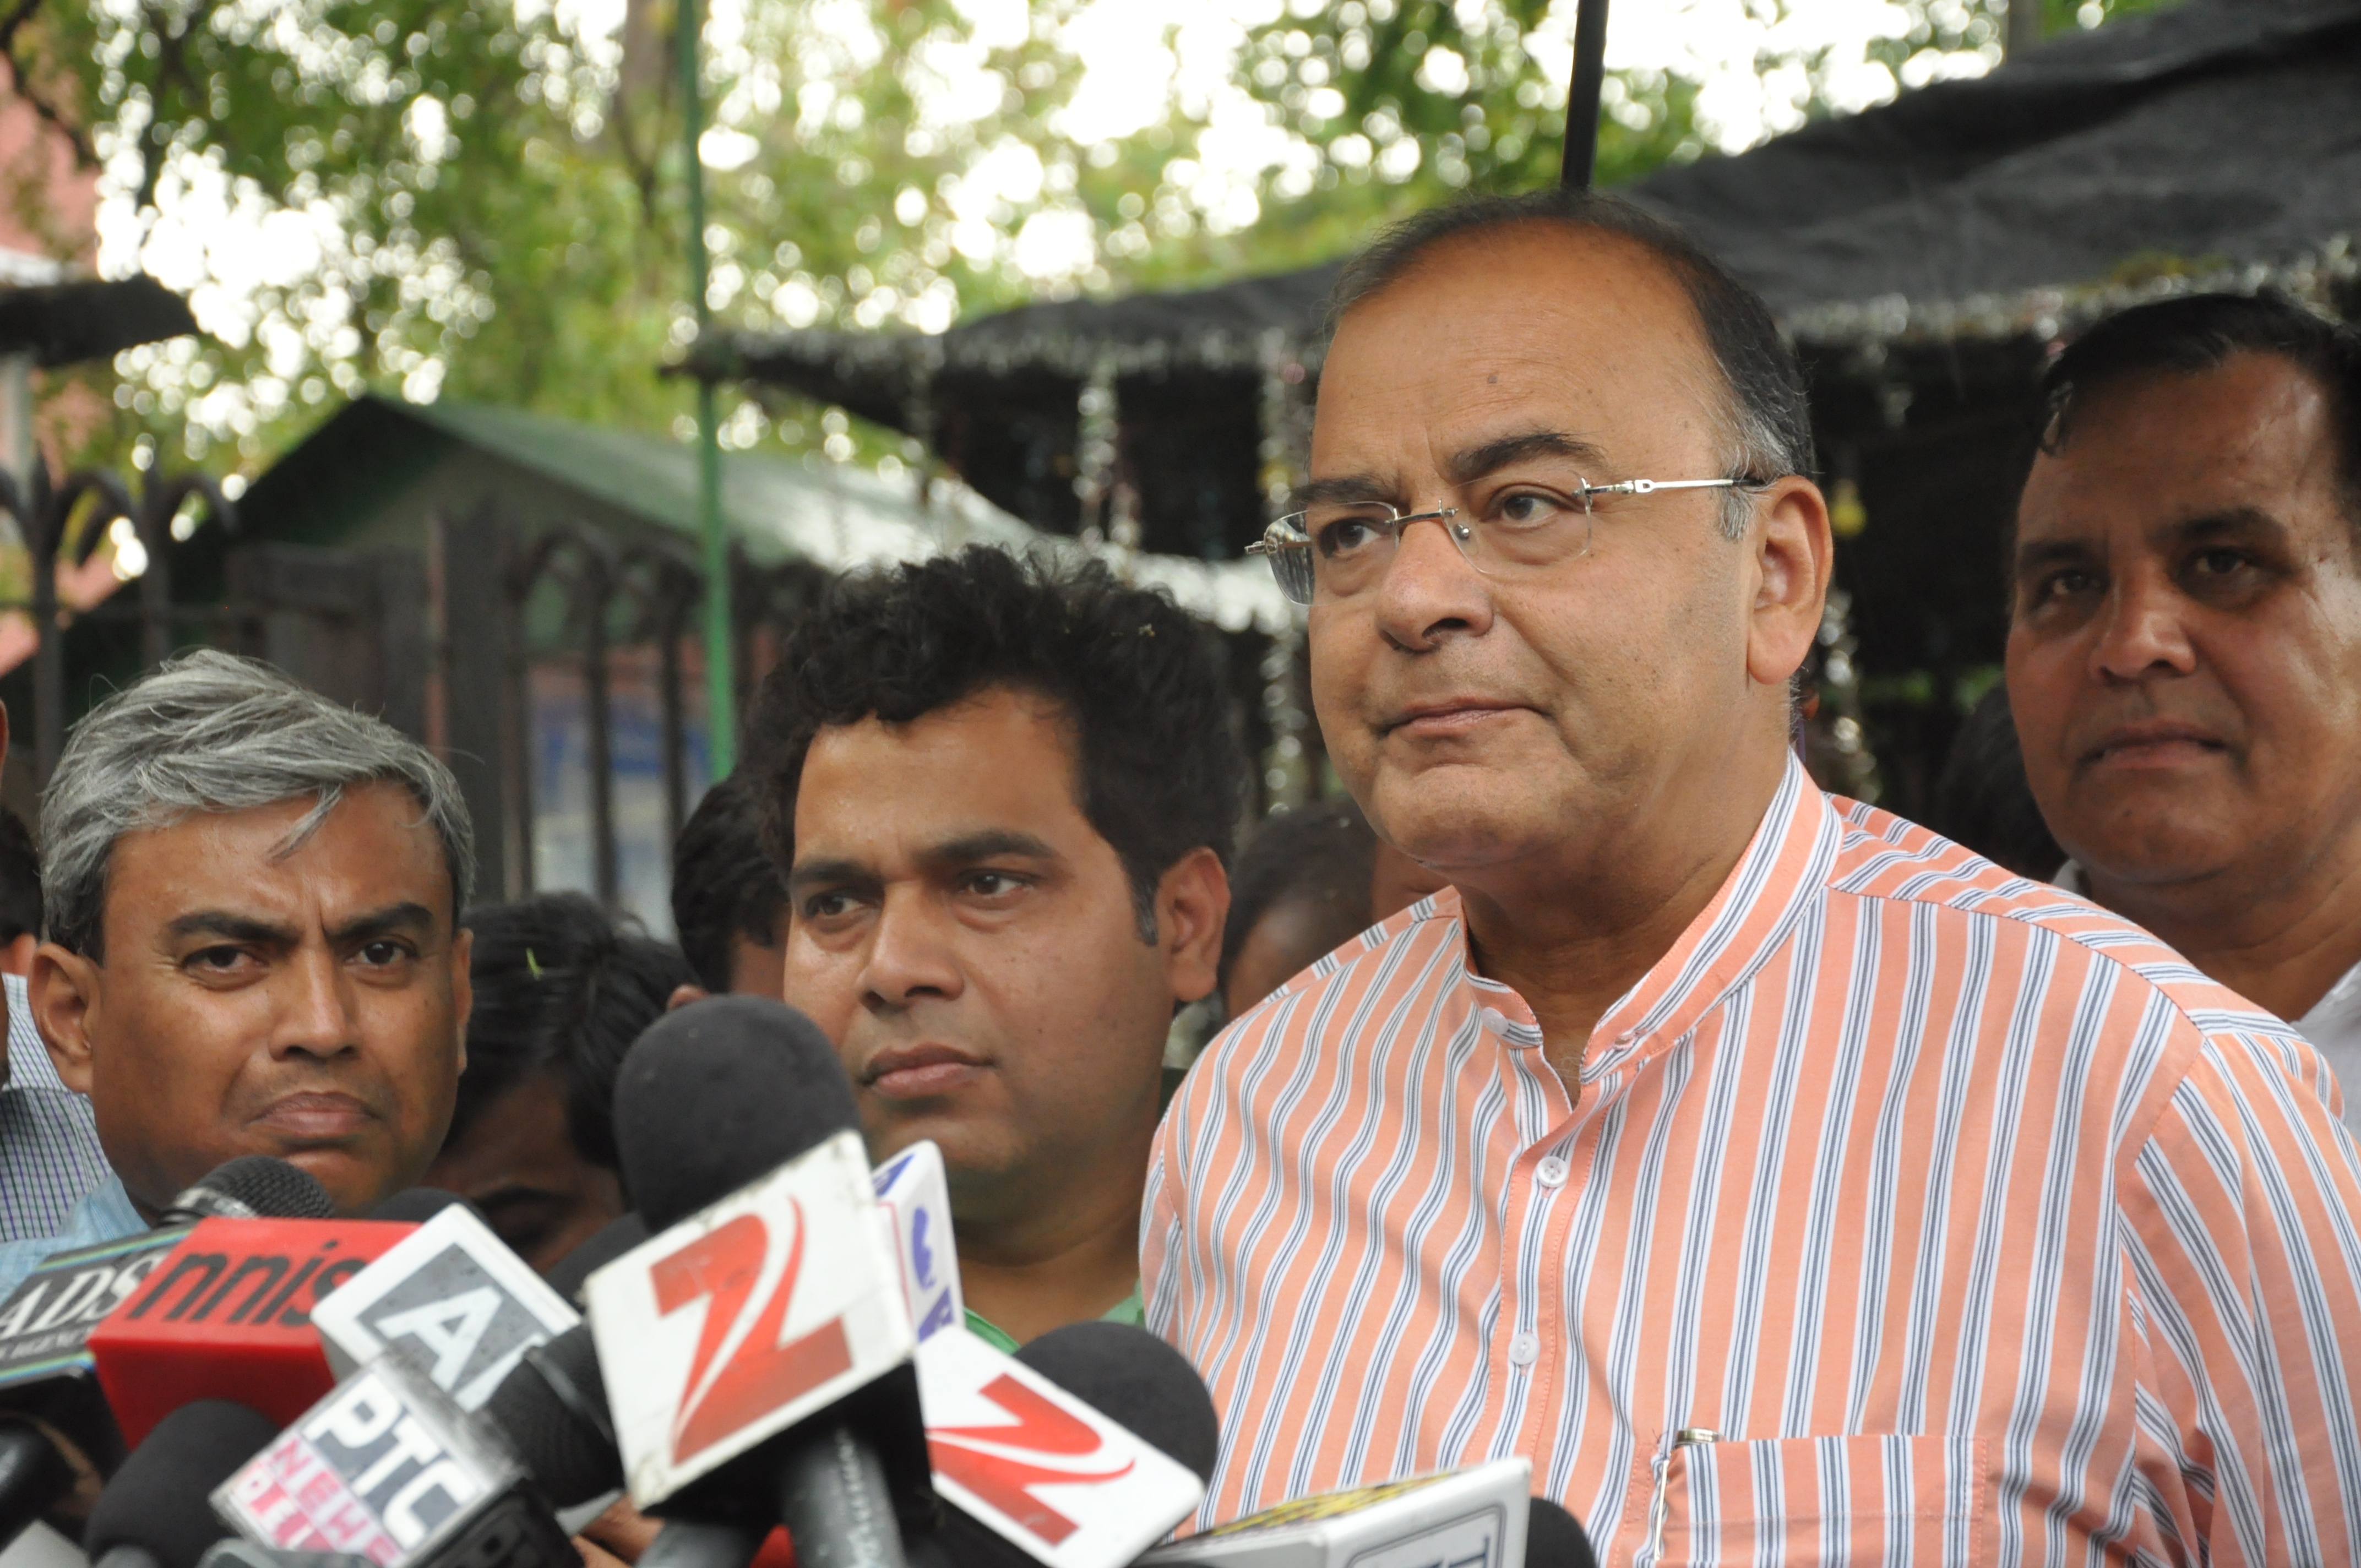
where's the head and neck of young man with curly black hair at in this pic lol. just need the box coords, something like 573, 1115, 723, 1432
748, 548, 1247, 1348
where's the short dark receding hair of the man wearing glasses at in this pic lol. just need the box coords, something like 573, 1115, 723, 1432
1327, 187, 1813, 538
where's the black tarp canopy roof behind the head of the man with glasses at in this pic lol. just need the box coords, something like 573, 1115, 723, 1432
701, 0, 2361, 430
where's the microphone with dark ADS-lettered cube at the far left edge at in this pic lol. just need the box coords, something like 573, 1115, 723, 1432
0, 1155, 333, 1547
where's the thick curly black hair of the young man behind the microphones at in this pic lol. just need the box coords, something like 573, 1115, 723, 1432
748, 546, 1247, 942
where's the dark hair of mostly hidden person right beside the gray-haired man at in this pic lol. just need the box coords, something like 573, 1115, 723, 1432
451, 892, 697, 1169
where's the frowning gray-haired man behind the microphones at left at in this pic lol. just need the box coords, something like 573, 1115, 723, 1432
0, 652, 475, 1292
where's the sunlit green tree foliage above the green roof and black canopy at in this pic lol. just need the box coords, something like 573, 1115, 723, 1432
0, 0, 2158, 484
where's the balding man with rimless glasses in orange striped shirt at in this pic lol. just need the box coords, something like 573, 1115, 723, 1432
1143, 191, 2361, 1563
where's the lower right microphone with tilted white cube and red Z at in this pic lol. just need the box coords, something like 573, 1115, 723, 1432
918, 1322, 1199, 1568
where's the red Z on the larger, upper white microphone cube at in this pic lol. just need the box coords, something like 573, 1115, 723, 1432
649, 1200, 852, 1464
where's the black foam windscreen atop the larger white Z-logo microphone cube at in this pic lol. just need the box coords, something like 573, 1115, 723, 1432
614, 997, 859, 1231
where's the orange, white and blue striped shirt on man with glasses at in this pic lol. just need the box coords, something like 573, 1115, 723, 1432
1143, 765, 2361, 1566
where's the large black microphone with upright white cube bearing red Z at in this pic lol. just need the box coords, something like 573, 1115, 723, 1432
583, 997, 930, 1568
